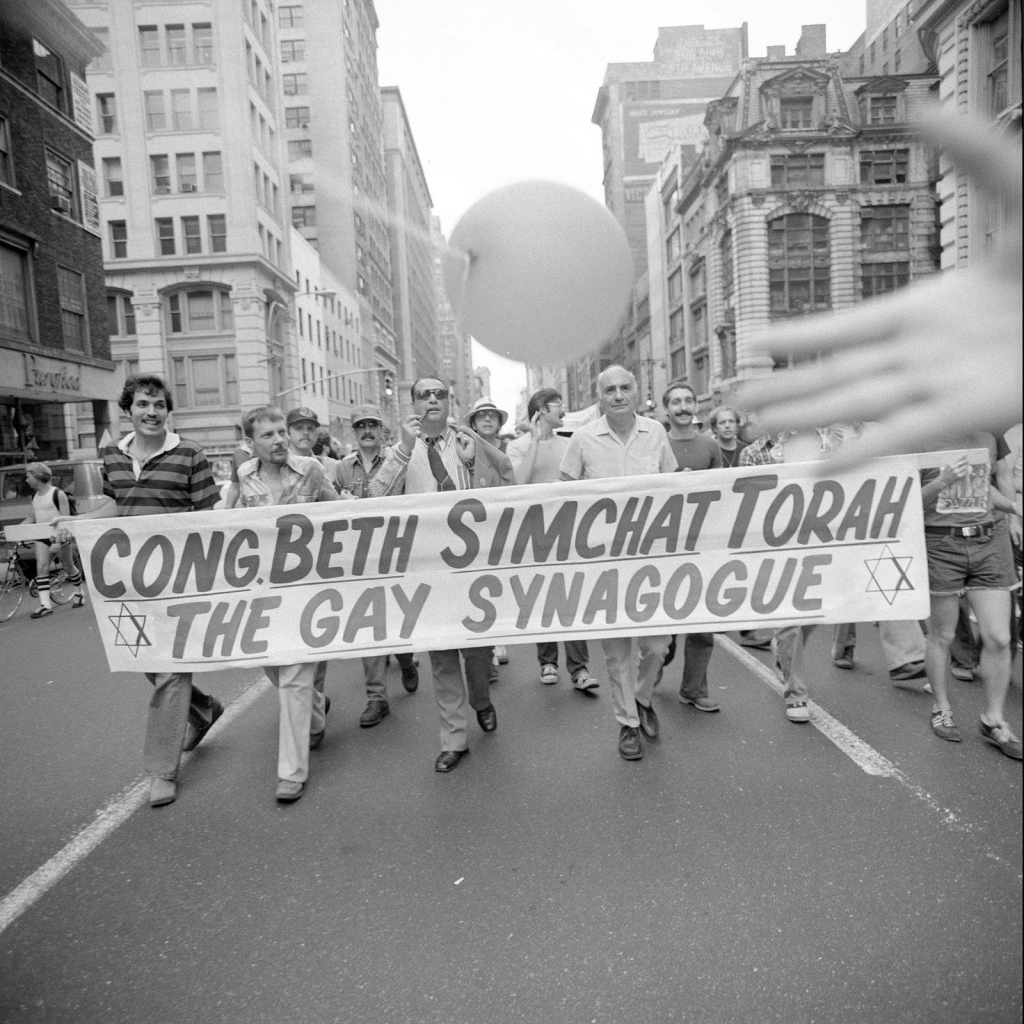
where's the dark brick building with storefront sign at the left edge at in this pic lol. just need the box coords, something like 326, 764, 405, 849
0, 0, 118, 463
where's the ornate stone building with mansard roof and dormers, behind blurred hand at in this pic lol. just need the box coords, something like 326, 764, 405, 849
647, 26, 938, 407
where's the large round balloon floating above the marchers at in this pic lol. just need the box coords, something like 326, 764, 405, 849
444, 181, 634, 366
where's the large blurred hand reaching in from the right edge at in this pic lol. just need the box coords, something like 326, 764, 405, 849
740, 117, 1022, 470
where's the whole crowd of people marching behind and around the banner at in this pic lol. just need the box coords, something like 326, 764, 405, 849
4, 367, 1021, 807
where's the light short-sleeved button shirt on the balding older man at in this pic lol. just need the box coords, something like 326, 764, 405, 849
561, 416, 677, 480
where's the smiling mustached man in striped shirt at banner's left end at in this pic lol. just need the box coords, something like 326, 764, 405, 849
58, 375, 224, 807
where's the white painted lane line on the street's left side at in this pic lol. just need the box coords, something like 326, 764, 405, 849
0, 677, 270, 933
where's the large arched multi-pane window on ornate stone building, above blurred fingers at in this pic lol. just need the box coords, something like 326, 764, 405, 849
768, 213, 831, 316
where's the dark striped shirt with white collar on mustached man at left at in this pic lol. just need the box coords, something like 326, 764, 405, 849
99, 431, 220, 515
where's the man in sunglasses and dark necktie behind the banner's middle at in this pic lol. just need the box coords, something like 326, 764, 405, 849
370, 377, 515, 772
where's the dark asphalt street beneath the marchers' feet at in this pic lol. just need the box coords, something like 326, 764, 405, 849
0, 607, 1022, 1024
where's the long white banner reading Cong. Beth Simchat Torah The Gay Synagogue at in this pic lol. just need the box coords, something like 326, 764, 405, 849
68, 457, 929, 672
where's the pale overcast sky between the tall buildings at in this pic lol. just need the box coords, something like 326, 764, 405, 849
376, 0, 865, 413
